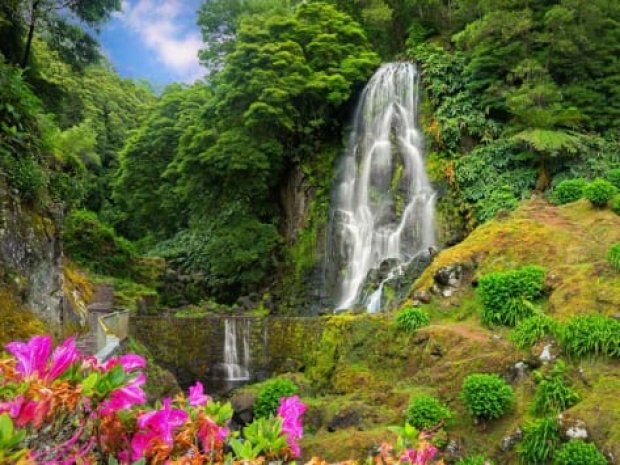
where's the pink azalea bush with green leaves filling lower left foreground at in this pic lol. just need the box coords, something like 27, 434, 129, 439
0, 336, 305, 465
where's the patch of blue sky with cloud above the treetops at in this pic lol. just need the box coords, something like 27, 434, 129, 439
99, 0, 205, 89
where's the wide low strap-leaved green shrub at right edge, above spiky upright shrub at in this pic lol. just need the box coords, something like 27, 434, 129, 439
560, 315, 620, 357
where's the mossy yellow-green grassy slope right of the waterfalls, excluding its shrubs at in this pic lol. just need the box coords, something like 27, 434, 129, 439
253, 200, 620, 464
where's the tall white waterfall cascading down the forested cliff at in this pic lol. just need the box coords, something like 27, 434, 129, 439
332, 63, 435, 312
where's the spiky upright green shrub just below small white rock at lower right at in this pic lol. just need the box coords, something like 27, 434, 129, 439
532, 361, 579, 415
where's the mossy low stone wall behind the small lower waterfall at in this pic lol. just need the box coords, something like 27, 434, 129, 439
129, 316, 323, 390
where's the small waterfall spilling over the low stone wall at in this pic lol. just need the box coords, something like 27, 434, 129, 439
223, 318, 250, 381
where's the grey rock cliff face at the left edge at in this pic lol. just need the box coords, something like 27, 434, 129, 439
0, 180, 64, 329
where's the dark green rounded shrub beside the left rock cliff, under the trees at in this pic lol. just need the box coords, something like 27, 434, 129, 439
63, 210, 136, 277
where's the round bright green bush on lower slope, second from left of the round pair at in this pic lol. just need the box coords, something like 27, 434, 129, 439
461, 373, 514, 420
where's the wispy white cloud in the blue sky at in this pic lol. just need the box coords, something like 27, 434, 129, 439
118, 0, 205, 82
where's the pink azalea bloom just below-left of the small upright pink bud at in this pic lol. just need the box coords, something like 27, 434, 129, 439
131, 398, 188, 460
